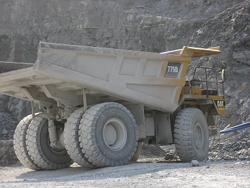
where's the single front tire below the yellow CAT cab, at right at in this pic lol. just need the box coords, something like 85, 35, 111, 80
174, 108, 209, 162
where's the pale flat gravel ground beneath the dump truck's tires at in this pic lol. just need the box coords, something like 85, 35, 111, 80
0, 158, 250, 188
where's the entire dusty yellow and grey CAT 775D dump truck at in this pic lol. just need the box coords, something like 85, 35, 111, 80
0, 42, 225, 170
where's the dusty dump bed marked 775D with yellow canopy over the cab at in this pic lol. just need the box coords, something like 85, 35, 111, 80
0, 42, 220, 113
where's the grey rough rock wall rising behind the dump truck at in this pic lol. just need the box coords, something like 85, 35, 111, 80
0, 0, 250, 139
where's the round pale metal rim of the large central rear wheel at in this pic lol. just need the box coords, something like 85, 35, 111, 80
102, 118, 127, 151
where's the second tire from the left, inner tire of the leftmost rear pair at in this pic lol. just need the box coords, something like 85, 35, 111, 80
27, 115, 73, 170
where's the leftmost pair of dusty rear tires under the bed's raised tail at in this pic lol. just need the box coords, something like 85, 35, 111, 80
14, 114, 73, 170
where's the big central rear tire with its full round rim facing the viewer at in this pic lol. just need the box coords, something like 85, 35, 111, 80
79, 102, 138, 167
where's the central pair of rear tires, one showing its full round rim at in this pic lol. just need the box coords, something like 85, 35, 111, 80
65, 102, 140, 167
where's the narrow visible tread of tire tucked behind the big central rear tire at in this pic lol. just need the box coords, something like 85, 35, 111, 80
64, 108, 94, 167
